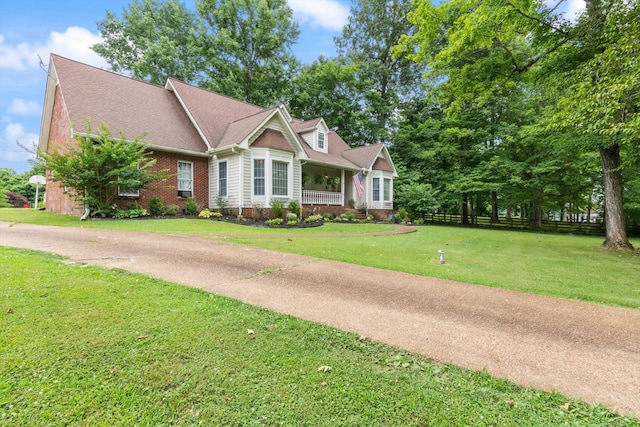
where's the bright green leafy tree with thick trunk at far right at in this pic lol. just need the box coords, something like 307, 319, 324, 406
398, 0, 640, 248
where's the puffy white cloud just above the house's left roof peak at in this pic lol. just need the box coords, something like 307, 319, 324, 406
0, 27, 107, 71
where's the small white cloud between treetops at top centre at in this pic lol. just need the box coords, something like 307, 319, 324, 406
287, 0, 349, 30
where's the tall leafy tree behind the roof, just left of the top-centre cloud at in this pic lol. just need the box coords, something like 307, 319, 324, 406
197, 0, 300, 105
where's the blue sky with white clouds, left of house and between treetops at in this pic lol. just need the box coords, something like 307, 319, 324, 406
0, 0, 350, 173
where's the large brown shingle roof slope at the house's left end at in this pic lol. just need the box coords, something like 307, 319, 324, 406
51, 54, 207, 153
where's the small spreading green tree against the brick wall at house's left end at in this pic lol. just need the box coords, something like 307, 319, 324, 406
40, 121, 167, 219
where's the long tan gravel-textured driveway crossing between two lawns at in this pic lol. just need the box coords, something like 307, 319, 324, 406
0, 222, 640, 416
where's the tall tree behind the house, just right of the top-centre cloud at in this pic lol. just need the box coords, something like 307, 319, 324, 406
335, 0, 422, 143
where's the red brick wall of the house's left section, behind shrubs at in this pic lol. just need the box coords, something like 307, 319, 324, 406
46, 87, 209, 216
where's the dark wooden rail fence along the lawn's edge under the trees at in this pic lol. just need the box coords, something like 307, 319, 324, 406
424, 214, 628, 236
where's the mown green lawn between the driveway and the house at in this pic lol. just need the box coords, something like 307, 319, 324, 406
0, 209, 640, 309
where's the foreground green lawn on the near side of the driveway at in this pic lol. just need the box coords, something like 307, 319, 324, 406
0, 247, 639, 426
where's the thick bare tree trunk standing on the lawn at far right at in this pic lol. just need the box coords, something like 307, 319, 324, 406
600, 144, 633, 250
